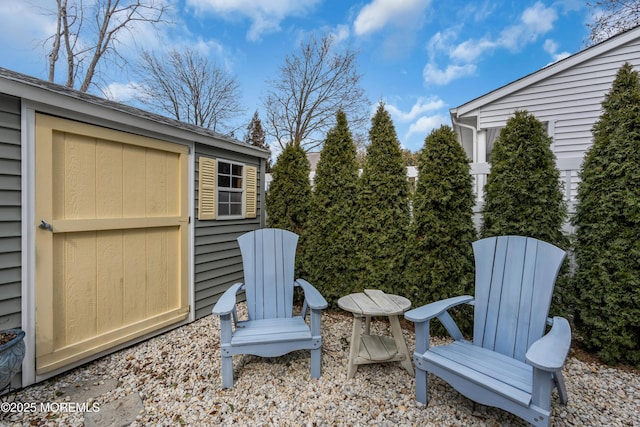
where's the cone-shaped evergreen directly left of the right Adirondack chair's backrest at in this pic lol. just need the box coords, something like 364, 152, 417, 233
405, 126, 477, 332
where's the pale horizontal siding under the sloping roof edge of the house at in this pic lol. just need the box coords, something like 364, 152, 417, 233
479, 41, 640, 158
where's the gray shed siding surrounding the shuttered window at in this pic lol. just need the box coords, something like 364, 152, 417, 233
194, 145, 264, 318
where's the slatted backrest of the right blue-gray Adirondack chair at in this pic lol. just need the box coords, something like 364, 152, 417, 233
473, 236, 566, 360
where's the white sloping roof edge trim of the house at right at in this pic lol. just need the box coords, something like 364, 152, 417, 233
449, 26, 640, 119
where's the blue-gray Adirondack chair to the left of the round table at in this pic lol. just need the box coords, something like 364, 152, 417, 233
213, 228, 327, 388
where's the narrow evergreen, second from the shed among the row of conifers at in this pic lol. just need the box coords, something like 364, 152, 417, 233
302, 111, 358, 305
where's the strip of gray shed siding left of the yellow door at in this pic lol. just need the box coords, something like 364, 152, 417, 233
0, 94, 22, 329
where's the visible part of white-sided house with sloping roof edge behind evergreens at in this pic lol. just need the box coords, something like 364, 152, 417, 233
452, 27, 640, 207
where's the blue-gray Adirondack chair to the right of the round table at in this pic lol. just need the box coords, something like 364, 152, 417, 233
405, 236, 571, 426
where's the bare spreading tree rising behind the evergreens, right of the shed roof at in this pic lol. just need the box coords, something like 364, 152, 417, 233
264, 35, 369, 151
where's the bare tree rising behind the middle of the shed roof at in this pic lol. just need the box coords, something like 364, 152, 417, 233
137, 49, 244, 132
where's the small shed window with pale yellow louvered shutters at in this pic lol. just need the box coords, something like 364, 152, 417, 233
198, 157, 257, 220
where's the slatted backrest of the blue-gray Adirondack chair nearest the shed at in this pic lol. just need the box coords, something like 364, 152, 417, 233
238, 228, 298, 320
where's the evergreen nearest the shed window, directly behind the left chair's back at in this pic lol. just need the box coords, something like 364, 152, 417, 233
267, 144, 311, 237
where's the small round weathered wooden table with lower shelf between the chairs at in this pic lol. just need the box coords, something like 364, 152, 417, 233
338, 289, 415, 378
